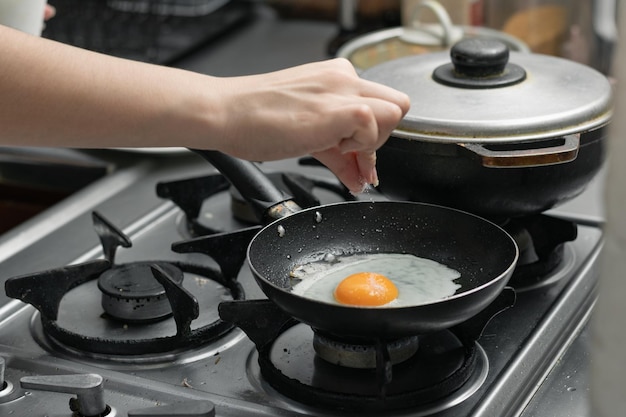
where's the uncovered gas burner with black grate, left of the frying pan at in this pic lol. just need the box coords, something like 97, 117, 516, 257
5, 212, 246, 362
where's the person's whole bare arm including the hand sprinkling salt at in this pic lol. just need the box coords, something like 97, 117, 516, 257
0, 26, 409, 191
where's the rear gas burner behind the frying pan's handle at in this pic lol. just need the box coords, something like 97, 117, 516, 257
156, 158, 356, 237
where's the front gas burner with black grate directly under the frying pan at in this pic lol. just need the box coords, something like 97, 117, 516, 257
219, 288, 515, 415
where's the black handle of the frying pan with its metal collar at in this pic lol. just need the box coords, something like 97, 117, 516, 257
192, 149, 301, 223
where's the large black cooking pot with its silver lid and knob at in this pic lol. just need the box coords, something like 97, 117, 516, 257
361, 39, 612, 219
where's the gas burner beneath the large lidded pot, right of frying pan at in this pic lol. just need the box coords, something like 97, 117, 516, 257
502, 214, 578, 289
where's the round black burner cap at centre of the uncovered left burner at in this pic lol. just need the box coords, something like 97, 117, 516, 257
98, 262, 183, 322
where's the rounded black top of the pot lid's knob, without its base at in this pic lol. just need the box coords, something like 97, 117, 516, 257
450, 38, 509, 77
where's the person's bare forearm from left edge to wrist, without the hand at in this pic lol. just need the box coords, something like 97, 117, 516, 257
0, 26, 223, 148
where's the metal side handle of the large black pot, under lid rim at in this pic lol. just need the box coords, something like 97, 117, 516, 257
460, 133, 580, 168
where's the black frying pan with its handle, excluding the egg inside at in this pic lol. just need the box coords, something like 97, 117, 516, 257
191, 151, 518, 340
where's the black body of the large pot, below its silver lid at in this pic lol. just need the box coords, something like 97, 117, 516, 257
377, 128, 607, 220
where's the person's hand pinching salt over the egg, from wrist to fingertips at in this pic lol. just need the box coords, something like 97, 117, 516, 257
210, 59, 410, 192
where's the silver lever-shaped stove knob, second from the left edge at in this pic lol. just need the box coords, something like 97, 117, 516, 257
20, 374, 108, 416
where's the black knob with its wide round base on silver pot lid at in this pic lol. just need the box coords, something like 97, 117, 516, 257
433, 38, 526, 88
